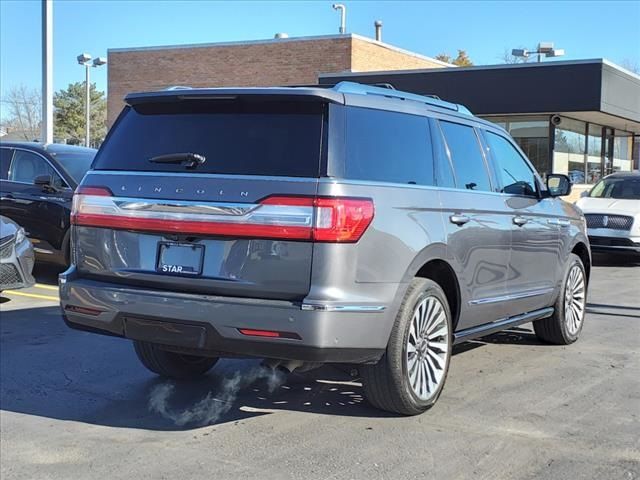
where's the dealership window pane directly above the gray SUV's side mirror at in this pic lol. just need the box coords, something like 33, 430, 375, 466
553, 118, 588, 183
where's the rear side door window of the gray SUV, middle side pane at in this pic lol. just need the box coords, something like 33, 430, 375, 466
440, 122, 491, 191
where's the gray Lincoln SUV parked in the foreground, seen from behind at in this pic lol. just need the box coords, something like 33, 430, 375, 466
60, 83, 591, 415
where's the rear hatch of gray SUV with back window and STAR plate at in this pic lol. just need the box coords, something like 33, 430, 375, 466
72, 95, 327, 300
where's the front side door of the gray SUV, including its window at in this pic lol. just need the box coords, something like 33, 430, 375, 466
483, 131, 565, 316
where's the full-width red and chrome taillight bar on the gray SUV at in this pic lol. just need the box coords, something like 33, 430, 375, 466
71, 187, 374, 243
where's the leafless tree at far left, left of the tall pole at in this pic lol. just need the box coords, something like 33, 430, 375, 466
2, 85, 41, 141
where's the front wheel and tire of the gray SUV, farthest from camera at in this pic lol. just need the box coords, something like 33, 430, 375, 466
533, 253, 587, 345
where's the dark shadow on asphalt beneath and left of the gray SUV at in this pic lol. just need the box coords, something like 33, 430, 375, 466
0, 307, 538, 430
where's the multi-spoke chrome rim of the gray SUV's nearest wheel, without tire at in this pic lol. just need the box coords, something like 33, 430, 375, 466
406, 296, 451, 400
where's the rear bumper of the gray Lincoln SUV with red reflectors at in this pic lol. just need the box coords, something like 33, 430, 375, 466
60, 268, 393, 363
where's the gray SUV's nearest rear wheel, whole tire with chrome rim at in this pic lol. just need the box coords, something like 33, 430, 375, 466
361, 278, 453, 415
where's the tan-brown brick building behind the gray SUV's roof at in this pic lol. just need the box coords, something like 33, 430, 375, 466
107, 34, 451, 126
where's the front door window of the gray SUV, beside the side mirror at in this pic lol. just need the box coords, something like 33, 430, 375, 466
485, 132, 537, 196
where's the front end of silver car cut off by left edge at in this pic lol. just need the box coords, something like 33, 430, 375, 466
0, 215, 35, 291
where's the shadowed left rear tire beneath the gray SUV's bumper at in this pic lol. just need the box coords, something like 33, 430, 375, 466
133, 340, 218, 380
